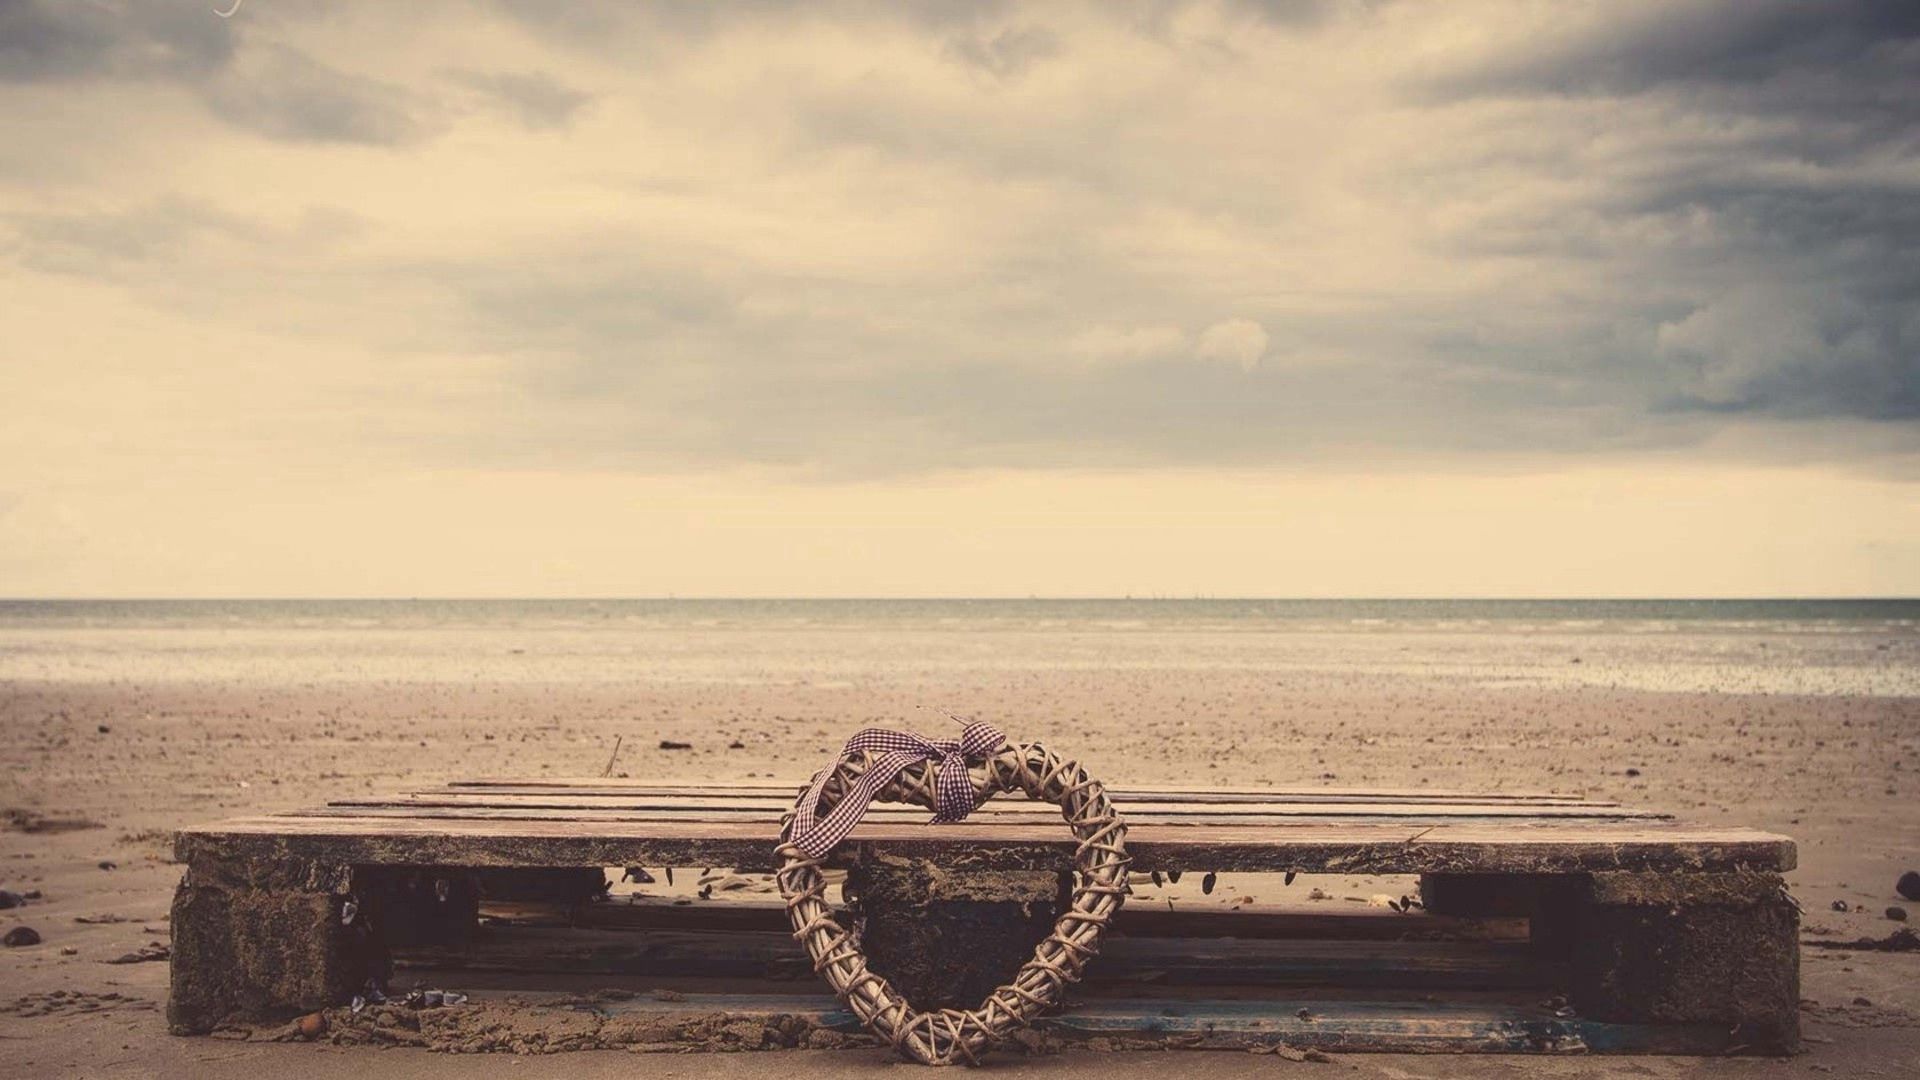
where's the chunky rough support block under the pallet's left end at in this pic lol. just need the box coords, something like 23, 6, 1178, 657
167, 857, 378, 1034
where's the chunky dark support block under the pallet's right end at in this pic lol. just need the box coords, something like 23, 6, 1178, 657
1569, 872, 1799, 1053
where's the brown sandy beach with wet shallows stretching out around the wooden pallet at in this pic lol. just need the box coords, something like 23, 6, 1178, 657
0, 599, 1920, 1078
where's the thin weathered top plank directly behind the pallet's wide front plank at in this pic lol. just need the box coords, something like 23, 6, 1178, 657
337, 794, 1670, 821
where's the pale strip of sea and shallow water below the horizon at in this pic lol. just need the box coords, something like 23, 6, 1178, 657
0, 598, 1920, 696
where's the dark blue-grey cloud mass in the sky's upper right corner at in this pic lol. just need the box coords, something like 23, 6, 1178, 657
1415, 0, 1920, 421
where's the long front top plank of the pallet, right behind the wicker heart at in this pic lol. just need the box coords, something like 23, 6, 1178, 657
175, 817, 1795, 874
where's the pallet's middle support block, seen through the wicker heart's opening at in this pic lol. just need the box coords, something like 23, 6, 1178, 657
845, 857, 1071, 1011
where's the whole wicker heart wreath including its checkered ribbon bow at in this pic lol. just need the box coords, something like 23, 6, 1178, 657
776, 723, 1127, 1065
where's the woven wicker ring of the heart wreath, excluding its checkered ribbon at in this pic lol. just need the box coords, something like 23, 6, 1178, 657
776, 742, 1127, 1065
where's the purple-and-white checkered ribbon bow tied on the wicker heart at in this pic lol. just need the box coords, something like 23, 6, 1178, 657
793, 721, 1006, 859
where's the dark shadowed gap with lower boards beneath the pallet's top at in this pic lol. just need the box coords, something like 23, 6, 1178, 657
353, 897, 1774, 1055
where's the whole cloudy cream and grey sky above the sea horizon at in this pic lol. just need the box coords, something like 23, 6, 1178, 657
0, 0, 1920, 596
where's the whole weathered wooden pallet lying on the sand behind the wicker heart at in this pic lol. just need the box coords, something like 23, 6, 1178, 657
169, 780, 1797, 1053
